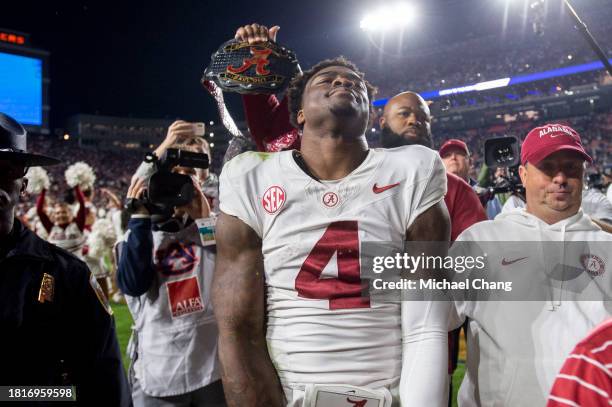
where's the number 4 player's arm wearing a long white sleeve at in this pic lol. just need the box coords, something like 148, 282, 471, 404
400, 201, 450, 406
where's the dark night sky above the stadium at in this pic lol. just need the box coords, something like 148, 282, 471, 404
0, 0, 604, 128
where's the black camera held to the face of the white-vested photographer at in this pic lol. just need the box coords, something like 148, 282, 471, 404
140, 148, 210, 222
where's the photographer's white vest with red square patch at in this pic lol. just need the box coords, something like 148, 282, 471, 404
126, 224, 220, 397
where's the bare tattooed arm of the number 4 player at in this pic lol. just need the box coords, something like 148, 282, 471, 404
212, 212, 285, 407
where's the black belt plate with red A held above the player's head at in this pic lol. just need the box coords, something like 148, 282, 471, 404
202, 39, 300, 93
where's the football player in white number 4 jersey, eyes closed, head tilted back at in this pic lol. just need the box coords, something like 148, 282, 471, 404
213, 58, 450, 407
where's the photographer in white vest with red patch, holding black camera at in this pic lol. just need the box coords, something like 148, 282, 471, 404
117, 133, 225, 406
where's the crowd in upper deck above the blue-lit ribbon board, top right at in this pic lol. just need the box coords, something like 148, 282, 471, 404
364, 8, 612, 97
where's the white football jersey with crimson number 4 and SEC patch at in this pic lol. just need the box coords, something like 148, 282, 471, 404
220, 146, 446, 389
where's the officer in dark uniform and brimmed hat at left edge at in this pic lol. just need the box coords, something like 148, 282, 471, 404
0, 113, 132, 406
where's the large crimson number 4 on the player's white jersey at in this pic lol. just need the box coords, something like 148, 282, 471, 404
295, 221, 370, 309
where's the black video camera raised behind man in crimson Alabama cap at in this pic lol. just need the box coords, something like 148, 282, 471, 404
484, 136, 525, 197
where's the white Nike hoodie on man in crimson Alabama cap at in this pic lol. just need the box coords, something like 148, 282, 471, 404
451, 209, 612, 407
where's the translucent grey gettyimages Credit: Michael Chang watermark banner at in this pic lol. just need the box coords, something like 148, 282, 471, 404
361, 242, 612, 301
